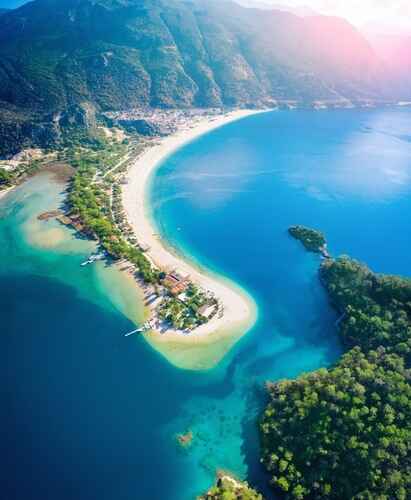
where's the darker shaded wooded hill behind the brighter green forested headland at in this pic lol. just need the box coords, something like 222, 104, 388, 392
320, 257, 411, 361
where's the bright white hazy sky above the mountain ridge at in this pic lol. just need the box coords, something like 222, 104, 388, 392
270, 0, 411, 31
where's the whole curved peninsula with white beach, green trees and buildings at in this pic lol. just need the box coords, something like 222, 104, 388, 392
3, 108, 265, 370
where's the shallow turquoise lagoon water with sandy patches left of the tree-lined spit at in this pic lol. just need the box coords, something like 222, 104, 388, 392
0, 169, 149, 332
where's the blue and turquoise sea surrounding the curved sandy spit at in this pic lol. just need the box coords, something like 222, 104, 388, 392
0, 109, 411, 500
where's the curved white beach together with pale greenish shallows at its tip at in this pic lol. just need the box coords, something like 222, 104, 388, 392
122, 110, 266, 370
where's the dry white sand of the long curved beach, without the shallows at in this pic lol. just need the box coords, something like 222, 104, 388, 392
123, 110, 261, 367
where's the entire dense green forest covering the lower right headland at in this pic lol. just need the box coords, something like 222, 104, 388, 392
260, 257, 411, 500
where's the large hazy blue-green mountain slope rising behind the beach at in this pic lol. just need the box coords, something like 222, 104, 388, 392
0, 0, 396, 154
